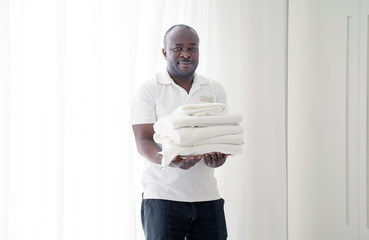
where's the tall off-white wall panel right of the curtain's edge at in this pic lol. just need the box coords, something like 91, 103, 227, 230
287, 0, 360, 240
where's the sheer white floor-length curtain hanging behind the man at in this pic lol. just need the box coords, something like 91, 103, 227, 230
0, 0, 287, 240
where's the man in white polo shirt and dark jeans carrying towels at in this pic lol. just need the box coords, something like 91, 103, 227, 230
132, 25, 227, 240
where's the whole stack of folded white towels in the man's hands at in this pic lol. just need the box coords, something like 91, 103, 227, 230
154, 103, 243, 168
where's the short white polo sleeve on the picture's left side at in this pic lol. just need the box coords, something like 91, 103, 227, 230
131, 81, 157, 125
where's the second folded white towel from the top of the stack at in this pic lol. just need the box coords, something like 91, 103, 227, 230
154, 113, 242, 132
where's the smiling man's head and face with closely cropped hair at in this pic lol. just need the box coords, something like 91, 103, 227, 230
163, 27, 199, 78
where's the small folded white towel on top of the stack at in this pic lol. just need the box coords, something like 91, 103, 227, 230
173, 103, 228, 116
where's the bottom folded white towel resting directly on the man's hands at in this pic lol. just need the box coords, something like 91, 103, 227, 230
159, 144, 242, 169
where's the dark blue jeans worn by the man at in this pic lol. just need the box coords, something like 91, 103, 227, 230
141, 199, 227, 240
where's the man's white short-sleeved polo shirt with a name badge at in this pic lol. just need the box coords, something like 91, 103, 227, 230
132, 71, 227, 202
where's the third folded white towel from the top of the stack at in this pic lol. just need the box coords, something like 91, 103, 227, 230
154, 125, 243, 146
